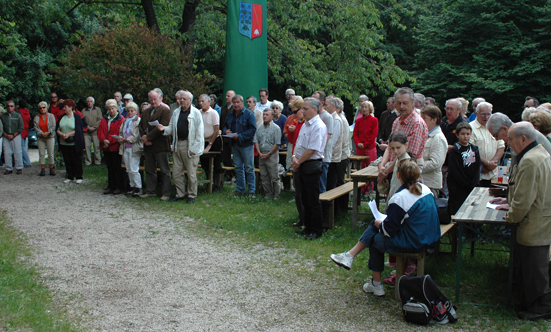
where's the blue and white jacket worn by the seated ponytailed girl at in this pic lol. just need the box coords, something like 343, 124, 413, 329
379, 184, 440, 252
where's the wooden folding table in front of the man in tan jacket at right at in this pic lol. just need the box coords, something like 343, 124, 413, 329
453, 187, 516, 306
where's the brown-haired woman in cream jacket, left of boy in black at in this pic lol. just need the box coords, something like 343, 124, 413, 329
421, 105, 448, 198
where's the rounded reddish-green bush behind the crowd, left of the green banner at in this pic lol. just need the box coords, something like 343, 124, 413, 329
55, 25, 207, 105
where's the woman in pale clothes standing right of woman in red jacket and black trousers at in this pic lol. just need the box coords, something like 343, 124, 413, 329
117, 101, 143, 197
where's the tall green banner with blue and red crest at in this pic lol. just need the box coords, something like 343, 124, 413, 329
224, 0, 268, 105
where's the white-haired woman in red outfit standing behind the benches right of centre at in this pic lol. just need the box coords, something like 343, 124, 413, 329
352, 101, 379, 192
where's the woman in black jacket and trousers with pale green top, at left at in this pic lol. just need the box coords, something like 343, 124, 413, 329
56, 99, 88, 184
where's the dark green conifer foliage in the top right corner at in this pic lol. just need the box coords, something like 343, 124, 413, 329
413, 0, 551, 119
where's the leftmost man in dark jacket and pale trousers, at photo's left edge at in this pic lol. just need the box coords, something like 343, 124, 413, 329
0, 100, 25, 175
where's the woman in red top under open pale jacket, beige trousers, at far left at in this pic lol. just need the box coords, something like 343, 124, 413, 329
34, 101, 55, 176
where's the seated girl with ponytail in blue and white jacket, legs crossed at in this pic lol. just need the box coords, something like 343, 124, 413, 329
331, 159, 440, 296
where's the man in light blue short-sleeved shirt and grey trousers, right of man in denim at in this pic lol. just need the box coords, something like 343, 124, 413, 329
254, 108, 281, 199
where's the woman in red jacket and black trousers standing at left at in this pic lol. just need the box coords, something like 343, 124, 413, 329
98, 99, 124, 195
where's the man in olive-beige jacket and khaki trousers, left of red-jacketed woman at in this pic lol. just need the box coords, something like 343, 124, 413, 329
82, 96, 102, 166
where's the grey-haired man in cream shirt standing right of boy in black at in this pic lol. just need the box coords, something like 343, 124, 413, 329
470, 101, 505, 187
